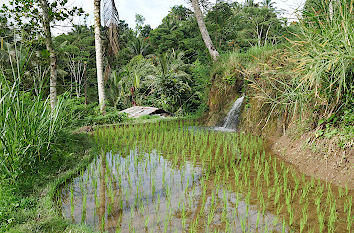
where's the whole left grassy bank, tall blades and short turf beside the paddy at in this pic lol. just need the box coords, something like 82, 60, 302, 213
0, 50, 125, 232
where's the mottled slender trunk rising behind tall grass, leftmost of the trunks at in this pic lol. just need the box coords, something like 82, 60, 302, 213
40, 0, 58, 110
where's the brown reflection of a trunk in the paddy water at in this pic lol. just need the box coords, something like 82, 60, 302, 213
98, 152, 123, 231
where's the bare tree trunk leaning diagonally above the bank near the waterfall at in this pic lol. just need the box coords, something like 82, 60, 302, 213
192, 0, 219, 62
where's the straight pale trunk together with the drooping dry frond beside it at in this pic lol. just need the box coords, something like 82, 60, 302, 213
94, 0, 119, 114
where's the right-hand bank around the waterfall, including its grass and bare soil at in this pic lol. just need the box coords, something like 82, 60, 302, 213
208, 0, 354, 188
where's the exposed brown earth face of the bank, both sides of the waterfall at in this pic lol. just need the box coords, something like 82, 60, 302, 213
205, 78, 354, 189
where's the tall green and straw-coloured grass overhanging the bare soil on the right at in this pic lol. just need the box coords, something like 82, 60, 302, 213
246, 0, 354, 129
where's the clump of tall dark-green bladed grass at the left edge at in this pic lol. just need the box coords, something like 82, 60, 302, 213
0, 48, 67, 184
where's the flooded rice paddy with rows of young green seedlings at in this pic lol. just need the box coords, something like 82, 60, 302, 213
58, 121, 353, 232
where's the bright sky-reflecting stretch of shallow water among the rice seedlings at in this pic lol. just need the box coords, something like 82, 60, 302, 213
62, 148, 282, 232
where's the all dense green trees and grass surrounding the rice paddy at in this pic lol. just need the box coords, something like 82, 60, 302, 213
0, 0, 354, 232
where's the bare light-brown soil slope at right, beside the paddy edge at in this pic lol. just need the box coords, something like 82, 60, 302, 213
272, 135, 354, 189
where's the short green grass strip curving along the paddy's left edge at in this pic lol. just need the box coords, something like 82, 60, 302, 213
0, 135, 94, 232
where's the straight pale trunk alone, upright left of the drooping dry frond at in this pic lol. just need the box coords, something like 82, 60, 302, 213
94, 0, 106, 114
